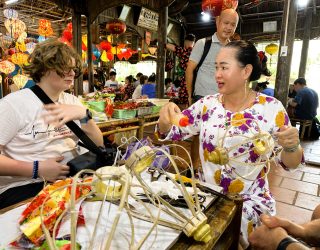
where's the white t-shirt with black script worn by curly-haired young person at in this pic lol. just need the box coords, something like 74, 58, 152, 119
0, 89, 82, 193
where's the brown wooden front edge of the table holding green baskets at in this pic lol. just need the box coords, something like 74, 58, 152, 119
97, 113, 159, 139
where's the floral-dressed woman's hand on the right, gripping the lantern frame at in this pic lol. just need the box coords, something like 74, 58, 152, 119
275, 126, 300, 148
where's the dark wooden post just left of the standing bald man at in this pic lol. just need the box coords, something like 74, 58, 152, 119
156, 7, 168, 98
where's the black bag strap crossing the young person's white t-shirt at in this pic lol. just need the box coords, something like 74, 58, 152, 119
30, 85, 102, 154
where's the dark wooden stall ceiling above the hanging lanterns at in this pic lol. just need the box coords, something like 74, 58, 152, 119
0, 0, 320, 41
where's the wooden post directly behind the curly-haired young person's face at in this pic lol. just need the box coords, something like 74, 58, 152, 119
72, 9, 83, 96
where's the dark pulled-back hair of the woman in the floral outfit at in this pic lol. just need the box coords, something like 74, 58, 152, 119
226, 40, 261, 81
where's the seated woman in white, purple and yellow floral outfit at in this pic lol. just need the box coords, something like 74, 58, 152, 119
158, 41, 303, 248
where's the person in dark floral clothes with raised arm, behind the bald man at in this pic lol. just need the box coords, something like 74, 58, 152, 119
166, 34, 196, 105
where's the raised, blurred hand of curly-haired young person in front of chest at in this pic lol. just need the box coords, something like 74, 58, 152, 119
42, 103, 86, 128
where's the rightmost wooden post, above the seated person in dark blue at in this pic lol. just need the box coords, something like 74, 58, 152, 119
299, 7, 313, 77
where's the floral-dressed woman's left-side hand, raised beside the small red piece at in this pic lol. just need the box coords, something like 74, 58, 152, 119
159, 102, 181, 133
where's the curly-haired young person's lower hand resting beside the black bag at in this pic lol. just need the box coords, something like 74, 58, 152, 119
38, 156, 69, 182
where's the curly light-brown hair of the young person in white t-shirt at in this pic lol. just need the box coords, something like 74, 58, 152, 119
23, 39, 82, 83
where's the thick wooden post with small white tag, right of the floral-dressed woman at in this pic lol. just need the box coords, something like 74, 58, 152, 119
275, 0, 298, 107
